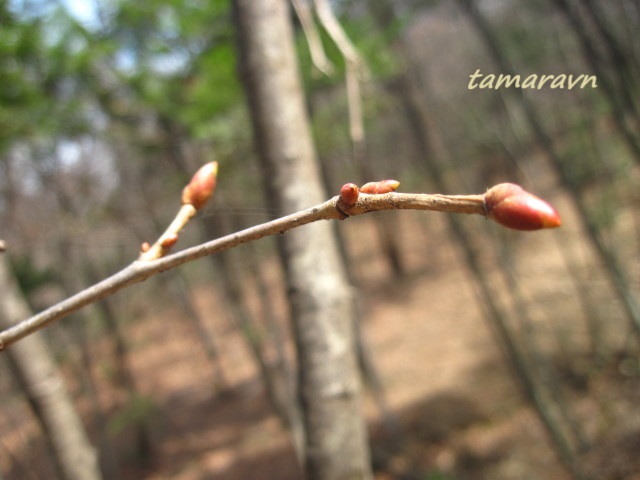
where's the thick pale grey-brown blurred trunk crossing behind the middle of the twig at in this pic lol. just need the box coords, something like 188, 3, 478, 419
233, 0, 371, 480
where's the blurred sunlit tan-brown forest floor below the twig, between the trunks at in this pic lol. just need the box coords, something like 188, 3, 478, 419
0, 197, 640, 480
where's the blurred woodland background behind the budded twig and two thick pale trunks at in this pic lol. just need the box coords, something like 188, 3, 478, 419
0, 0, 640, 479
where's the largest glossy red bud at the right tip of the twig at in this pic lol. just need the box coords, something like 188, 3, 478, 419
484, 183, 561, 230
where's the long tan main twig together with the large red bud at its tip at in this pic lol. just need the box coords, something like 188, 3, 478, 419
0, 182, 560, 351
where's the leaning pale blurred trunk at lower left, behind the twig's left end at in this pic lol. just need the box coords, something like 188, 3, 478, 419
0, 255, 101, 480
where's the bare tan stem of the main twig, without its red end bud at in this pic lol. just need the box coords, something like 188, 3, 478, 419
0, 192, 485, 351
